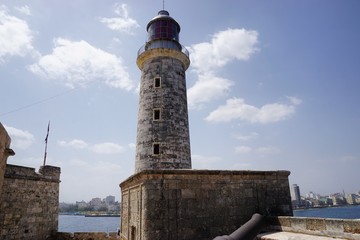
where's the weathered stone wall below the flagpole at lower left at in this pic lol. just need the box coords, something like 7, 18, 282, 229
0, 164, 60, 240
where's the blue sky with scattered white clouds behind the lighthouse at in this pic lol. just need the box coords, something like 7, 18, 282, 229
0, 0, 360, 202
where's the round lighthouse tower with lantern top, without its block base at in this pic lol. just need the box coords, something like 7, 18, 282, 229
135, 10, 191, 173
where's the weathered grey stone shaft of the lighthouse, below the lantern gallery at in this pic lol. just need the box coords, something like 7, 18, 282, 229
135, 49, 191, 172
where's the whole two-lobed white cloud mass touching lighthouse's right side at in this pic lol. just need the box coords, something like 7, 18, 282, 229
188, 29, 258, 108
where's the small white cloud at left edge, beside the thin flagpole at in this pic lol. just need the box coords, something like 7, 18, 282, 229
4, 126, 34, 149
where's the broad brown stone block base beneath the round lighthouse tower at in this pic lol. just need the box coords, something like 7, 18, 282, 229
120, 170, 292, 240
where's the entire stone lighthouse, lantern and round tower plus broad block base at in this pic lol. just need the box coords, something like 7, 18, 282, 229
119, 10, 292, 240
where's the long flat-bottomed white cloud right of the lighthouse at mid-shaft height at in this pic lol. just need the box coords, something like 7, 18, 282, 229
205, 98, 296, 124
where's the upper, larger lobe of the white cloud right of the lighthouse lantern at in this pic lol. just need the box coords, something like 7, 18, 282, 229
189, 28, 258, 72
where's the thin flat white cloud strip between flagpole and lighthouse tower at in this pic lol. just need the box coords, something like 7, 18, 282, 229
58, 139, 125, 154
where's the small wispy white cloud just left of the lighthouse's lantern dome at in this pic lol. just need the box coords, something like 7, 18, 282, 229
100, 3, 139, 34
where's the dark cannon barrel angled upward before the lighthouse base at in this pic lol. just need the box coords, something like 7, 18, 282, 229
213, 213, 267, 240
